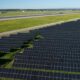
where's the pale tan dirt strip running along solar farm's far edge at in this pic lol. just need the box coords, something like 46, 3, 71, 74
0, 18, 80, 38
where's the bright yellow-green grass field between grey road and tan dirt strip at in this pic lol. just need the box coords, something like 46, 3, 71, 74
0, 14, 80, 32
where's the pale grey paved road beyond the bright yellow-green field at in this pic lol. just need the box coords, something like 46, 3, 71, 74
0, 14, 69, 21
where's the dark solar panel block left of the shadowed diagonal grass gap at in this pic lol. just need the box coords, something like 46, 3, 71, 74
0, 33, 35, 52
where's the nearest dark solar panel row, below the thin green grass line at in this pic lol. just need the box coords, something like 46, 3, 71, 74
0, 69, 80, 80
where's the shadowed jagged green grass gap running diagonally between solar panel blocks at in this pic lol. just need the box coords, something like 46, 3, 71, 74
0, 33, 44, 68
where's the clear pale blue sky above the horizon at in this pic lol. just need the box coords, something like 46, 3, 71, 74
0, 0, 80, 9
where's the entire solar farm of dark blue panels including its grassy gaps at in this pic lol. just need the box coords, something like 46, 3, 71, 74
0, 16, 80, 80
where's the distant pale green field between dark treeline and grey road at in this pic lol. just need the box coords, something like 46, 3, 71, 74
0, 10, 80, 17
